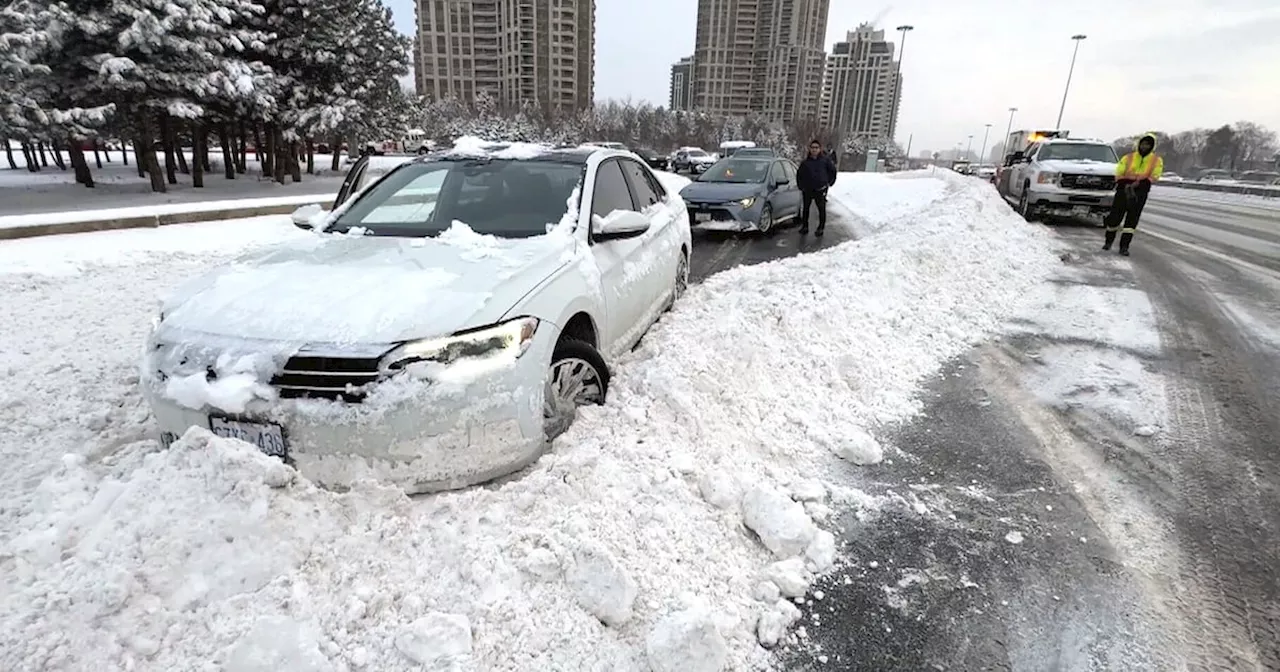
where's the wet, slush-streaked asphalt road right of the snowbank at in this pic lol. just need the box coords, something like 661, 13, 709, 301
781, 185, 1280, 672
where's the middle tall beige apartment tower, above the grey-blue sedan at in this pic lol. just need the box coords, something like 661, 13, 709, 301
692, 0, 831, 122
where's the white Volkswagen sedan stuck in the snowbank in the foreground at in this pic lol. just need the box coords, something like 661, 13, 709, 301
141, 138, 691, 492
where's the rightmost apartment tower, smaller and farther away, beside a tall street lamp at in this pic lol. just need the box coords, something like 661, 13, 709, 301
822, 23, 902, 138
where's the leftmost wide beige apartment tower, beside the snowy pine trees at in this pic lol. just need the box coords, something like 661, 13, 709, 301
413, 0, 595, 111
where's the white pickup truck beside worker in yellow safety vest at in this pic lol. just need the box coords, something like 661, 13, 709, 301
1005, 138, 1119, 221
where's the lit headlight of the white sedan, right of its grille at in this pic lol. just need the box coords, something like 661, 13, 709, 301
379, 317, 538, 374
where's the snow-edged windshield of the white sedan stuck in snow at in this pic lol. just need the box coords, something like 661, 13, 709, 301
329, 159, 582, 238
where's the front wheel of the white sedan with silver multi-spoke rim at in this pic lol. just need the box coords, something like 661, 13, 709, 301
543, 338, 609, 440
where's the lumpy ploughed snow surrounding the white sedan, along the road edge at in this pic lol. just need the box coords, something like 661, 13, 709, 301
0, 172, 1061, 672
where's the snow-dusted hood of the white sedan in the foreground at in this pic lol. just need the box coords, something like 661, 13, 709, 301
161, 225, 576, 344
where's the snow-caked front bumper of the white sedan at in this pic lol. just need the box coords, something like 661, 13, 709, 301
141, 323, 558, 494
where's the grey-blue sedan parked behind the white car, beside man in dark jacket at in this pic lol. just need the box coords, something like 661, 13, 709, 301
680, 154, 800, 234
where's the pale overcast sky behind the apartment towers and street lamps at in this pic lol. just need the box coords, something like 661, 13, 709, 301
378, 0, 1280, 155
